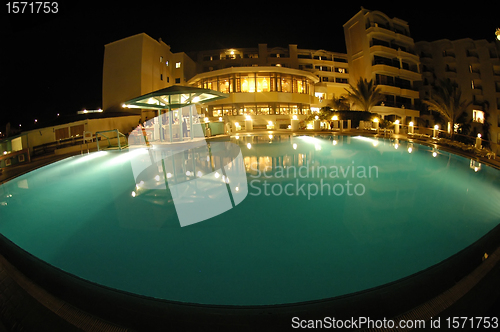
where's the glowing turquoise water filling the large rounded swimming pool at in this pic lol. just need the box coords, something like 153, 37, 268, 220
0, 136, 500, 305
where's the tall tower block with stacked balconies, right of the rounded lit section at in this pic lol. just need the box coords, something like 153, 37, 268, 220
344, 8, 421, 119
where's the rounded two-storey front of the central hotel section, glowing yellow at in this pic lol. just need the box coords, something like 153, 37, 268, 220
189, 66, 319, 128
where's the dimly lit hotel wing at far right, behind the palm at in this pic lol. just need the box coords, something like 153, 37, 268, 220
416, 38, 500, 143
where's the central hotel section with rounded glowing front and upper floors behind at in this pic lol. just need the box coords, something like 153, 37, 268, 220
188, 44, 349, 128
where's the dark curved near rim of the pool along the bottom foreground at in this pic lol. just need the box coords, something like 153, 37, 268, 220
0, 225, 500, 331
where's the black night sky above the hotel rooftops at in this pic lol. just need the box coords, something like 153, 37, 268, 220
0, 0, 500, 131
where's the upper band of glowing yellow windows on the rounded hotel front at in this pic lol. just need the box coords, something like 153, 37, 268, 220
198, 73, 312, 94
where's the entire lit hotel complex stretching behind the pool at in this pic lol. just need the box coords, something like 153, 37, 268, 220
103, 8, 500, 147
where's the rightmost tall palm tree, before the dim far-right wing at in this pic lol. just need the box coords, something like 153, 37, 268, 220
422, 78, 472, 138
